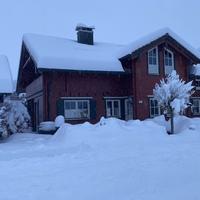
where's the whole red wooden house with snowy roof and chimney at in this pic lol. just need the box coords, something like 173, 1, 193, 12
17, 25, 200, 130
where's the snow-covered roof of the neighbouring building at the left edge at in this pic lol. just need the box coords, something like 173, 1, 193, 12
0, 55, 13, 93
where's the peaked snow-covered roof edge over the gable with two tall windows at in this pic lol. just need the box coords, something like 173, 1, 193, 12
119, 28, 200, 59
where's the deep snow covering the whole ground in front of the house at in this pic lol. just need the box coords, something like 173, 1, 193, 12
0, 117, 200, 200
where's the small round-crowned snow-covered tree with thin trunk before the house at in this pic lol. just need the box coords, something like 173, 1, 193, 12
153, 70, 194, 134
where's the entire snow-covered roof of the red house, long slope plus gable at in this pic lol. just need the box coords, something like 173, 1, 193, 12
23, 27, 200, 72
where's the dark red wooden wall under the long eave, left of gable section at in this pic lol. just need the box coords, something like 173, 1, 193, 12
43, 72, 133, 123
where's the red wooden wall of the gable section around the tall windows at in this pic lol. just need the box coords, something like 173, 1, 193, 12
132, 44, 189, 119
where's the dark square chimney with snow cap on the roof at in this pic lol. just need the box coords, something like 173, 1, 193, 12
76, 24, 95, 45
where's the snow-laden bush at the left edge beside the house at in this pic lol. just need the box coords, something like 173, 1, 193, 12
0, 99, 30, 136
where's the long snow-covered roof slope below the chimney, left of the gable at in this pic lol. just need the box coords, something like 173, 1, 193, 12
23, 34, 124, 72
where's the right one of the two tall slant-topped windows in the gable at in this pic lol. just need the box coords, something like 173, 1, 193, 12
164, 49, 174, 75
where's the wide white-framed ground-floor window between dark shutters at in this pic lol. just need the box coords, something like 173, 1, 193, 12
64, 100, 90, 119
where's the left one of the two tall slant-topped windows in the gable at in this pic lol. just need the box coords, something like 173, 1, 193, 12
148, 47, 159, 74
